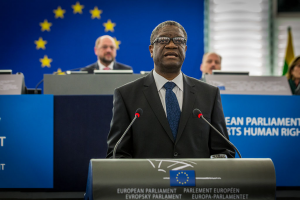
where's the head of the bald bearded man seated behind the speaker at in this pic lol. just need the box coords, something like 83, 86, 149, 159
94, 37, 117, 64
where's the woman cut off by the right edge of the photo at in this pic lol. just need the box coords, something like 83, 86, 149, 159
286, 56, 300, 94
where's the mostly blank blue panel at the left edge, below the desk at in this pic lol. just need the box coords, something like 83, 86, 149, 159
0, 95, 53, 188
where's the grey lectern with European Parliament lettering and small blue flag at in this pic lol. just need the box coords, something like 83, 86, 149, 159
85, 159, 276, 200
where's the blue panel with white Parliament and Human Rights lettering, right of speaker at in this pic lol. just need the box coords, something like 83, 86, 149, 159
222, 95, 300, 187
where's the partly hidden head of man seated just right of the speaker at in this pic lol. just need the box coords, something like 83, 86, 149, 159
200, 53, 221, 74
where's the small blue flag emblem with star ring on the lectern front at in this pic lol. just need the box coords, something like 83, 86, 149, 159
170, 170, 196, 187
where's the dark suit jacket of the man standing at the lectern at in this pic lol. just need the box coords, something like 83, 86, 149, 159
107, 72, 234, 158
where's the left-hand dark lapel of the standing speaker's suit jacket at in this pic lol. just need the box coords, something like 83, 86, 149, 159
143, 72, 174, 142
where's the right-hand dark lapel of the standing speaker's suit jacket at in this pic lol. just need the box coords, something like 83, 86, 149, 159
175, 75, 196, 143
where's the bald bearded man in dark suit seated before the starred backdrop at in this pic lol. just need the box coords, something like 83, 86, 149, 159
81, 35, 132, 74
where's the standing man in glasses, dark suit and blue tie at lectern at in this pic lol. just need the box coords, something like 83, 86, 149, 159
107, 21, 235, 158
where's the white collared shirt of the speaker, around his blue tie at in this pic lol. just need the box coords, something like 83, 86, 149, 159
153, 70, 183, 115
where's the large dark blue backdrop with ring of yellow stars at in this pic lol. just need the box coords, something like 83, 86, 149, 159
0, 0, 204, 88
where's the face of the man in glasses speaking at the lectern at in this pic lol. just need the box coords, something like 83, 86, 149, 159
149, 25, 187, 73
